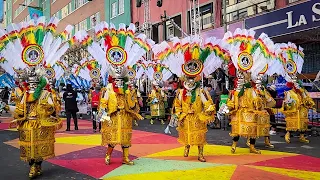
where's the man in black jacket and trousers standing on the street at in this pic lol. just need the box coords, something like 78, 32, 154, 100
63, 84, 79, 131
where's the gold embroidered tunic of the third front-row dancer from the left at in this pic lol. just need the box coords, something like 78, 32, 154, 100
174, 88, 215, 146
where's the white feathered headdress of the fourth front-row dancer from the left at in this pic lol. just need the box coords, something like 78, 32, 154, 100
223, 28, 275, 79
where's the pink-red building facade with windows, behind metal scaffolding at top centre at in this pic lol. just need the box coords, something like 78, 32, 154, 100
131, 0, 221, 42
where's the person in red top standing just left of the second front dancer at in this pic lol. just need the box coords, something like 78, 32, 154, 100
89, 86, 101, 132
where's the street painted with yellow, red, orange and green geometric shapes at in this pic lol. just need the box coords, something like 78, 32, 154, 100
0, 114, 320, 180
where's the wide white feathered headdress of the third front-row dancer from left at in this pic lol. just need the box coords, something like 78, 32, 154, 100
152, 35, 230, 77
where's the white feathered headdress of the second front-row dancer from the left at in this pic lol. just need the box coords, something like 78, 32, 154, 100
76, 22, 154, 81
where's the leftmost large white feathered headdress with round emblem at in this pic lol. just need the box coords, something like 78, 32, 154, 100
0, 17, 72, 81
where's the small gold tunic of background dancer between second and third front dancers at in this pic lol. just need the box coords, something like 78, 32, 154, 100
149, 89, 166, 118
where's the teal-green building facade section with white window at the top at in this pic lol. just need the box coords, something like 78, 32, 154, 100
104, 0, 131, 26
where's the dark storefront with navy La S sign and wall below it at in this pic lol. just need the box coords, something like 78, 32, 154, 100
245, 0, 320, 79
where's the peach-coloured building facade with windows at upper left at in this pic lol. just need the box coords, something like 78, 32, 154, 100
5, 0, 108, 34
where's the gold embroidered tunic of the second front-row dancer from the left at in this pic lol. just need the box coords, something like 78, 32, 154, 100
100, 84, 143, 146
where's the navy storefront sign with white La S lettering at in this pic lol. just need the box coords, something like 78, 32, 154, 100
245, 0, 320, 37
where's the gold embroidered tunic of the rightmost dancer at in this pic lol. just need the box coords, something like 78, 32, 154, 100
282, 89, 315, 132
